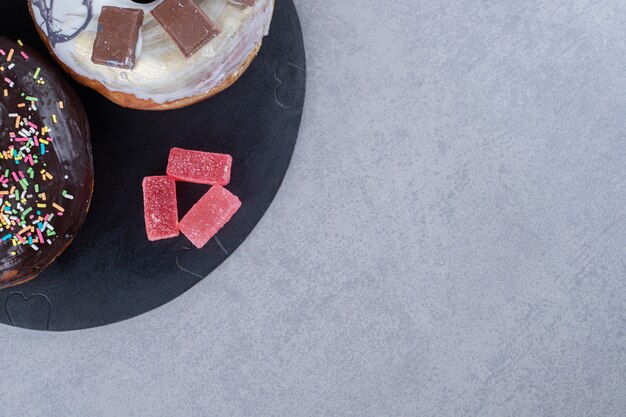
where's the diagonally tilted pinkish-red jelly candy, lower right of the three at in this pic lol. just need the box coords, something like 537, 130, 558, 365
178, 185, 241, 248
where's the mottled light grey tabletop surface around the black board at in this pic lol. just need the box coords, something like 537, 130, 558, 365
0, 0, 626, 417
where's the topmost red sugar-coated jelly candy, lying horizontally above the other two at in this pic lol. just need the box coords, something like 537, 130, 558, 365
167, 148, 233, 185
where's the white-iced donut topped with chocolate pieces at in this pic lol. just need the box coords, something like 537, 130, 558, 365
28, 0, 274, 110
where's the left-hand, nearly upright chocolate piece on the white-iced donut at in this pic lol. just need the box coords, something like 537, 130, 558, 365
91, 6, 143, 69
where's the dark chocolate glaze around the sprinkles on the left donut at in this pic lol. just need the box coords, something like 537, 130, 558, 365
0, 36, 93, 288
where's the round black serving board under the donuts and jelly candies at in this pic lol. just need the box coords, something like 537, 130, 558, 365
0, 0, 305, 331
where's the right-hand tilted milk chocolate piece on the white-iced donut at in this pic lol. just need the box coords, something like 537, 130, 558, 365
152, 0, 220, 57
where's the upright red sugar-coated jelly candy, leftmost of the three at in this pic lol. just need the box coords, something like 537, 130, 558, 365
142, 176, 178, 240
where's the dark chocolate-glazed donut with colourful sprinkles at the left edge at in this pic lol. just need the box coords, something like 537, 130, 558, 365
0, 36, 93, 288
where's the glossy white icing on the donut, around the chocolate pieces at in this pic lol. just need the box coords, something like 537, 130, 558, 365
29, 0, 274, 104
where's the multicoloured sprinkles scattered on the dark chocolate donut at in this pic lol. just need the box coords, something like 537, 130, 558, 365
0, 41, 74, 256
